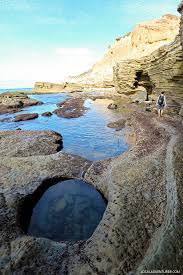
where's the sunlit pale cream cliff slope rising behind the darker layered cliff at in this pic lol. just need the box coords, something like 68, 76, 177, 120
68, 15, 180, 86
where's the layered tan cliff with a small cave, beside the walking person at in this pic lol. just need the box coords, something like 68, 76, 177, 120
114, 22, 183, 114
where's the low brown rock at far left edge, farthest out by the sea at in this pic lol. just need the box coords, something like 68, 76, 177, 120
0, 92, 42, 114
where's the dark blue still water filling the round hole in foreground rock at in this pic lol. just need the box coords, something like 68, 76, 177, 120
28, 180, 106, 241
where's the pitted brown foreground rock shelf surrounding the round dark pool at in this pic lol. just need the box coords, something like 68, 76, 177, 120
0, 112, 183, 275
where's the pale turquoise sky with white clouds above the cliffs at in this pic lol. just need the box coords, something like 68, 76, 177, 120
0, 0, 180, 88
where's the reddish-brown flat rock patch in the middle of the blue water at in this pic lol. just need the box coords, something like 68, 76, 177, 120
54, 98, 87, 118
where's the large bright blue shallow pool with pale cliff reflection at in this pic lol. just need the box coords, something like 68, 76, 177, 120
0, 94, 128, 160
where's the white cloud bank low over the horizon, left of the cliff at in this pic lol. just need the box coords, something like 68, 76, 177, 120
0, 47, 101, 87
